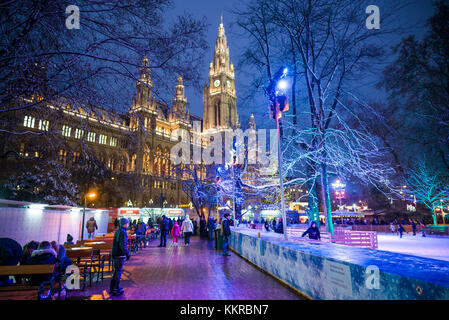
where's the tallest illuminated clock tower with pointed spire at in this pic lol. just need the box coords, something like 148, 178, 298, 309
203, 17, 240, 131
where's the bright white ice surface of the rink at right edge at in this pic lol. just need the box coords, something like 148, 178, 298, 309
377, 233, 449, 261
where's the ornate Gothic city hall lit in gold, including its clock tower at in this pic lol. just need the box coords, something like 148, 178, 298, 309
0, 17, 255, 208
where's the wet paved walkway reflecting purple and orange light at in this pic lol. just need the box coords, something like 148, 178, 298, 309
70, 237, 300, 300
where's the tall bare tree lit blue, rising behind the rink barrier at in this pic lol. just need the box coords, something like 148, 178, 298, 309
234, 0, 402, 232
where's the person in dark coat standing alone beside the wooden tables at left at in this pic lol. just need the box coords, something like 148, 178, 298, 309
109, 218, 130, 296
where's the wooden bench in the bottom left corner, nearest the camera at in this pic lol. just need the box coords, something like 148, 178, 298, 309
0, 264, 57, 300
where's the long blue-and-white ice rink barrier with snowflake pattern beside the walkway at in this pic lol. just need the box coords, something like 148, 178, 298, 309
229, 228, 449, 300
